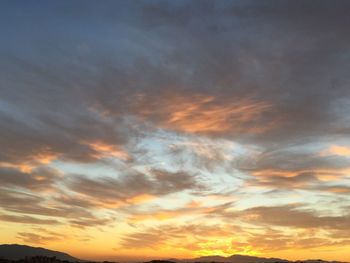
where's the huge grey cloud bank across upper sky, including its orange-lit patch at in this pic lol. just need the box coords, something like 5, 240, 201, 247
2, 1, 349, 151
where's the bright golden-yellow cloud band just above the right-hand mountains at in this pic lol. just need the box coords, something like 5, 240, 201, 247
119, 210, 350, 255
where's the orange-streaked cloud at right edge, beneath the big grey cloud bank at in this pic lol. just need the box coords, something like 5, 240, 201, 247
232, 146, 350, 191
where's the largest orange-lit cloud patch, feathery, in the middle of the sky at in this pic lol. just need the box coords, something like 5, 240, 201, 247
138, 94, 272, 134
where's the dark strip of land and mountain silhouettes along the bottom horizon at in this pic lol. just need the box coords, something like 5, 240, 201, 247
0, 244, 346, 263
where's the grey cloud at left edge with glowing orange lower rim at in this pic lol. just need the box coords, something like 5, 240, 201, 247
0, 91, 133, 168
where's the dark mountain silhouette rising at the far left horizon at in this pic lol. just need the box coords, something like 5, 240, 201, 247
0, 244, 81, 262
